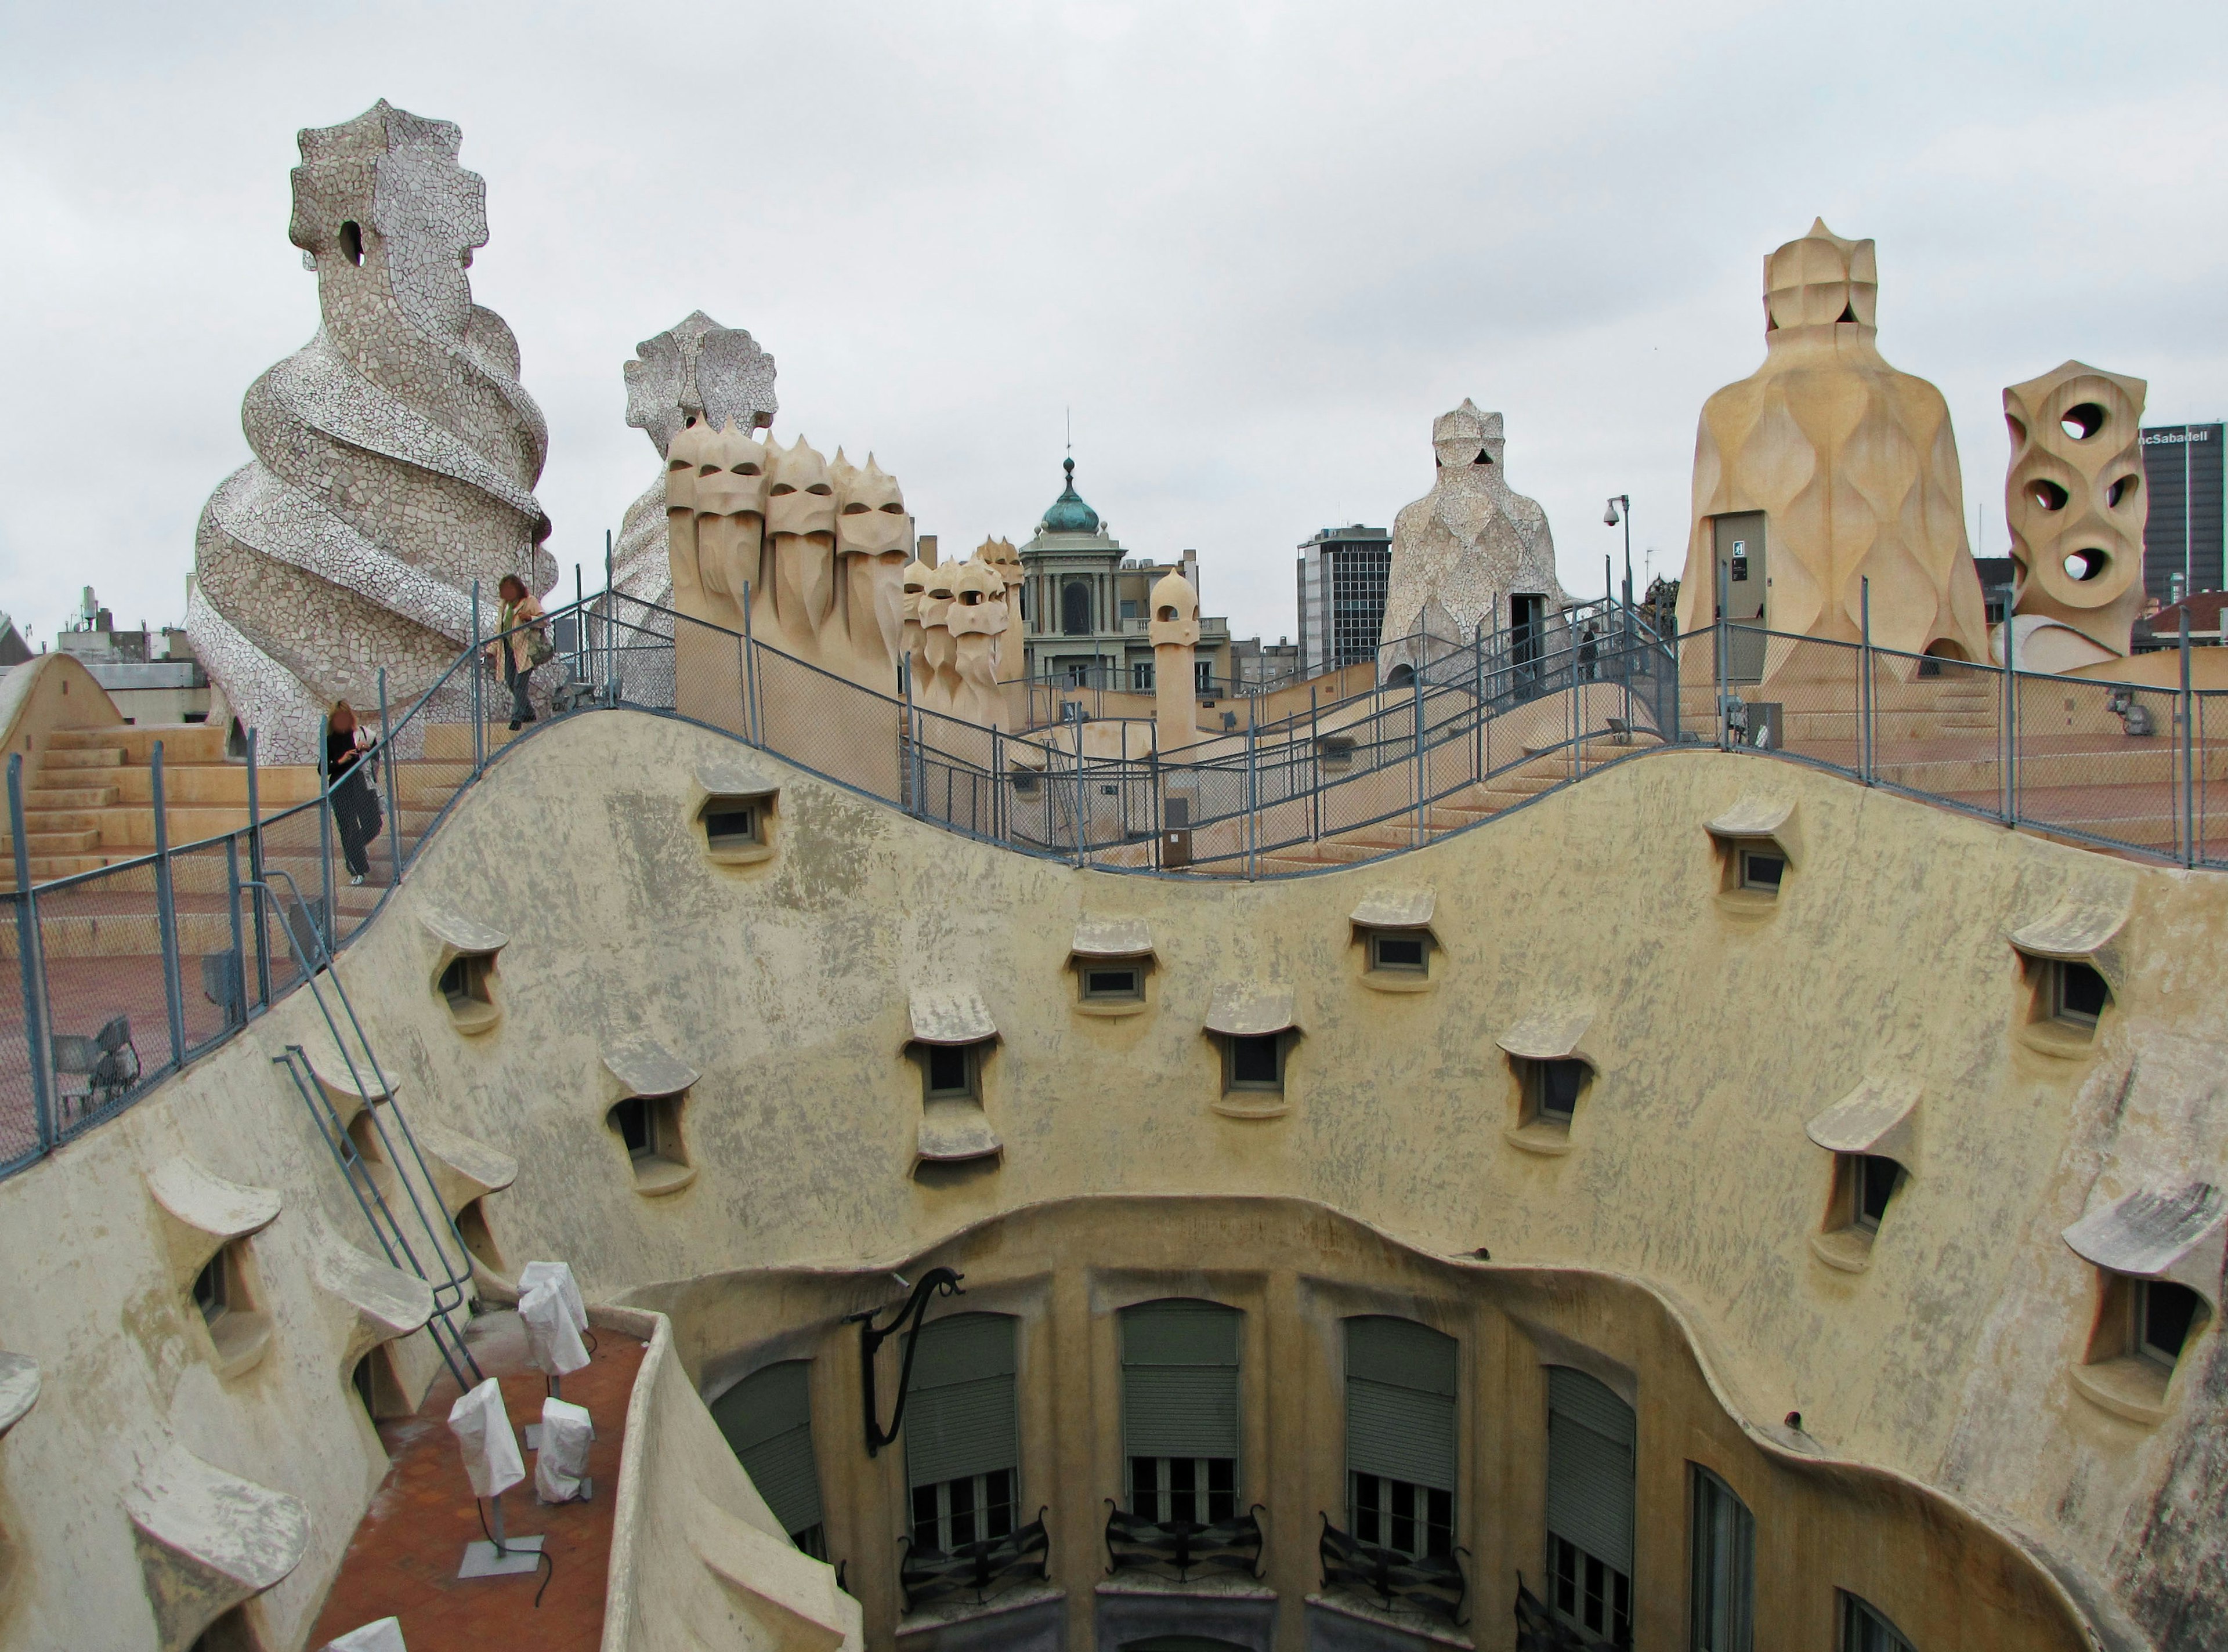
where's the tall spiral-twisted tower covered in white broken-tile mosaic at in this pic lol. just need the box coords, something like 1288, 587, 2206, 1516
185, 103, 557, 762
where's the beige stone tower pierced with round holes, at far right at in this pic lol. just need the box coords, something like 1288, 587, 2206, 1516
1994, 361, 2150, 670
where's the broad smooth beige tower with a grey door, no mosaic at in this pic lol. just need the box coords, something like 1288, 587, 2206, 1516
1678, 218, 1987, 682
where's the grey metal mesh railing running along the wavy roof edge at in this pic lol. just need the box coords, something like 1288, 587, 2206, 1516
0, 590, 2228, 1175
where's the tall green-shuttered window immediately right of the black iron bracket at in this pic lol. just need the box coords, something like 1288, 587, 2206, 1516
905, 1314, 1021, 1554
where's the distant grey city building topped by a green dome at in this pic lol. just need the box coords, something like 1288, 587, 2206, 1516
1021, 459, 1232, 695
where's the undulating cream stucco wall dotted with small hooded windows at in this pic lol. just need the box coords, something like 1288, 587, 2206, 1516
0, 712, 2228, 1647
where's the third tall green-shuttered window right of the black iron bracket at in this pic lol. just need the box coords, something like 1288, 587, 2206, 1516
1346, 1314, 1459, 1559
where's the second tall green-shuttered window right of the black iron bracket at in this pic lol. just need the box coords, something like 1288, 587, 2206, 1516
1121, 1298, 1241, 1525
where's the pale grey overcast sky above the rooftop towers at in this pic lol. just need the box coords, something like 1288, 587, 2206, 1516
0, 0, 2228, 641
